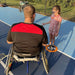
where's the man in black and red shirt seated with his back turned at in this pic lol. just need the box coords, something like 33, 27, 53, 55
7, 5, 48, 74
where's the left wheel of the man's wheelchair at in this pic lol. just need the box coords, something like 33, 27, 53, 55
5, 49, 12, 75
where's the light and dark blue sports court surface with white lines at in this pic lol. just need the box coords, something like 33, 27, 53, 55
0, 7, 75, 75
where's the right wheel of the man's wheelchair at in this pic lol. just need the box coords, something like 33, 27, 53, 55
41, 50, 49, 74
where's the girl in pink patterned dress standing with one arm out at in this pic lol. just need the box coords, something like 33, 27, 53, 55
43, 5, 62, 45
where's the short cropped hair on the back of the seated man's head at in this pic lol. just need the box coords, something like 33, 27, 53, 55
24, 5, 35, 18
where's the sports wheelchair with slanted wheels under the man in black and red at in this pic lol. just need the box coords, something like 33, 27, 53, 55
5, 49, 49, 75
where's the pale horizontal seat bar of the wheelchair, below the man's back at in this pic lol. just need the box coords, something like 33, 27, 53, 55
13, 52, 40, 62
